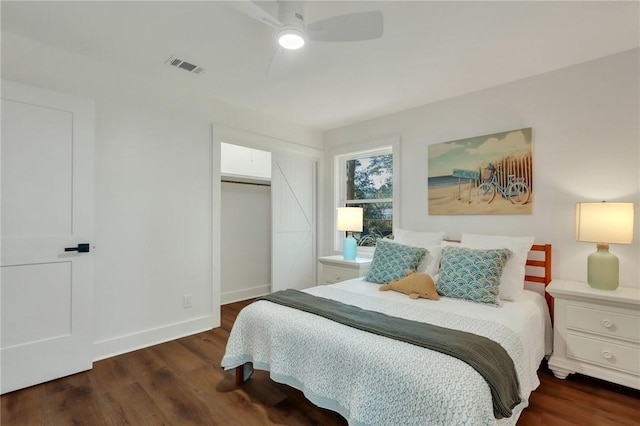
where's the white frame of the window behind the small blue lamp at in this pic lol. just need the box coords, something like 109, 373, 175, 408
332, 136, 400, 257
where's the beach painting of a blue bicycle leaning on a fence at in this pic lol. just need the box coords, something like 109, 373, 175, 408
427, 127, 534, 215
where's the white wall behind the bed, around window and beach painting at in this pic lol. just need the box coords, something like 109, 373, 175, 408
323, 49, 640, 287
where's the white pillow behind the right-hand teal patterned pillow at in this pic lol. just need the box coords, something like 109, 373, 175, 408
460, 233, 535, 300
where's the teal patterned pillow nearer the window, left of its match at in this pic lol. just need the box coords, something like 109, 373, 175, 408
364, 239, 427, 284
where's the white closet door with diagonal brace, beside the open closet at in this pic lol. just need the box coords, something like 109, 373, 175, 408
271, 153, 316, 291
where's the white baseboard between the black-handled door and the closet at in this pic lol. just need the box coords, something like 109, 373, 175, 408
93, 315, 220, 362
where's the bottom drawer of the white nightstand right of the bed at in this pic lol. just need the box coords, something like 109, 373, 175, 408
567, 334, 640, 374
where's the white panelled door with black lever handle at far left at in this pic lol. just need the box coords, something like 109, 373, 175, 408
0, 81, 94, 393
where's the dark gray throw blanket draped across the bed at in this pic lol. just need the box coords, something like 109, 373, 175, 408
256, 289, 521, 419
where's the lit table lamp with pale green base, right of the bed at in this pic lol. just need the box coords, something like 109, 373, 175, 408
576, 201, 633, 290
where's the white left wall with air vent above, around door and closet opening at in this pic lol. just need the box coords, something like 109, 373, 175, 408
1, 32, 322, 359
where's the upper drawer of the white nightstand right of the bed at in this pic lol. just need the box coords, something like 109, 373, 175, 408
567, 304, 640, 343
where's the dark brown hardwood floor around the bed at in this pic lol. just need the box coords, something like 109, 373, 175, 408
0, 302, 640, 426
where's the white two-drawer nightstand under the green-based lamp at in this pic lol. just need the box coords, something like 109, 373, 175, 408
547, 280, 640, 389
